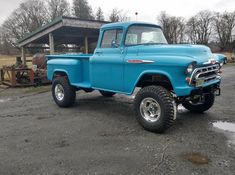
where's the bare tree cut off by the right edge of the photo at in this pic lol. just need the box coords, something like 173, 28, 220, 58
214, 11, 235, 50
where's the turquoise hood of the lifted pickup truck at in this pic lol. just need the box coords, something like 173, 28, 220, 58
138, 44, 213, 65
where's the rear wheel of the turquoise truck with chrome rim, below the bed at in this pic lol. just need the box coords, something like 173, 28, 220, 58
52, 77, 76, 107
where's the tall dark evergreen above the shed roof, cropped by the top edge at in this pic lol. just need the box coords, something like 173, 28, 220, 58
73, 0, 94, 20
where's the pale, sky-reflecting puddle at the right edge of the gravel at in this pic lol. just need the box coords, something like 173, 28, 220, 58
212, 121, 235, 148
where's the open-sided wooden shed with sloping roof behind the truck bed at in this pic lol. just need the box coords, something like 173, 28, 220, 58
18, 16, 108, 64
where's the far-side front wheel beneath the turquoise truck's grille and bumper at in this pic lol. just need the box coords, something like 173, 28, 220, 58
182, 93, 215, 113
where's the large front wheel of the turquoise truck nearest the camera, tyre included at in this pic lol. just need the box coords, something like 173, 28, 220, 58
134, 86, 176, 133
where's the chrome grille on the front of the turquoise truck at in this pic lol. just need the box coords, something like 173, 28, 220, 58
190, 64, 220, 85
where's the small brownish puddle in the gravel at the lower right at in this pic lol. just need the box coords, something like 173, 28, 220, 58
182, 152, 210, 165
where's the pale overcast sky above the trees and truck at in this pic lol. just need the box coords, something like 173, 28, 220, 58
0, 0, 235, 24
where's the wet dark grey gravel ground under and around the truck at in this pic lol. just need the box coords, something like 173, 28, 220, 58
0, 66, 235, 175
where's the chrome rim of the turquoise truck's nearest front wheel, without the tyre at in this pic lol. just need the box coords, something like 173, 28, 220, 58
140, 97, 161, 122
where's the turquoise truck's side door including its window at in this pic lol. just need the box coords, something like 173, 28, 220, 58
90, 29, 124, 92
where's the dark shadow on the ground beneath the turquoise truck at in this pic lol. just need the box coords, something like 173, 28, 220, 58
68, 93, 213, 134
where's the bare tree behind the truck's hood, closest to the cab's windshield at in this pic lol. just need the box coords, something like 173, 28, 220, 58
158, 12, 185, 44
